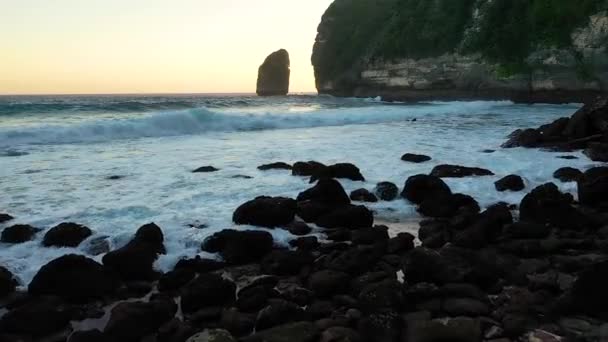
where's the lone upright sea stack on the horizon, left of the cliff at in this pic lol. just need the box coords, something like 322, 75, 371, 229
256, 49, 290, 96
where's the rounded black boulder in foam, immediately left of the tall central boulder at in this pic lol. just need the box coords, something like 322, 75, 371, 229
232, 196, 297, 228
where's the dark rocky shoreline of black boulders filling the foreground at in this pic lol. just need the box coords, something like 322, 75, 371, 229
0, 98, 608, 342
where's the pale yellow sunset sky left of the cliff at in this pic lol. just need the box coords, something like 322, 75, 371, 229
0, 0, 332, 94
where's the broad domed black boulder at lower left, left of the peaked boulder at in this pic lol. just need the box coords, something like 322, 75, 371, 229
28, 254, 119, 302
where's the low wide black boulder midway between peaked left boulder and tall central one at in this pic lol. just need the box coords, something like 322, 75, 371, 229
202, 229, 274, 264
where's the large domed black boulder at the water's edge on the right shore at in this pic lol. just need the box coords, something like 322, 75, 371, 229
519, 183, 588, 229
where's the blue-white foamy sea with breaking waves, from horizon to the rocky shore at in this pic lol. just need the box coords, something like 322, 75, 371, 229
0, 95, 591, 284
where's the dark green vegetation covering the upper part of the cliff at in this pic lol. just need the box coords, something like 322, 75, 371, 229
313, 0, 608, 76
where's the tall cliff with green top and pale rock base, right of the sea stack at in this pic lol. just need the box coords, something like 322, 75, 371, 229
312, 0, 608, 102
